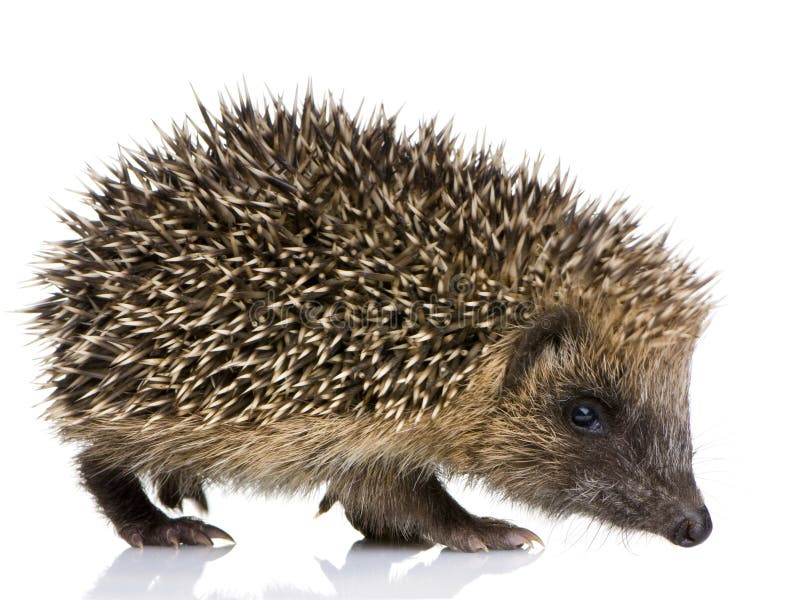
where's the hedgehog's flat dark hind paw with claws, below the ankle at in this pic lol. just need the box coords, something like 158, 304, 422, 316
119, 517, 235, 548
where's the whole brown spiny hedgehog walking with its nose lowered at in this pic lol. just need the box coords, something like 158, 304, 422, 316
32, 86, 711, 550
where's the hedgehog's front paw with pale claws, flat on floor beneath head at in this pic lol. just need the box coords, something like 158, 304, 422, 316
434, 517, 544, 552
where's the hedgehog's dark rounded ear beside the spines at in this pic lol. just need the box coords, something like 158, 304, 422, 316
503, 308, 579, 389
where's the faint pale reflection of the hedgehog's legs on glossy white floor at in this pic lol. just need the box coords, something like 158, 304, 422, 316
85, 541, 537, 600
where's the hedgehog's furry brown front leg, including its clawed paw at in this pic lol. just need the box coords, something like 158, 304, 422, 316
319, 468, 544, 552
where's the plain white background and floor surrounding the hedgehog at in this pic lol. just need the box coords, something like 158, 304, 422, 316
0, 0, 800, 599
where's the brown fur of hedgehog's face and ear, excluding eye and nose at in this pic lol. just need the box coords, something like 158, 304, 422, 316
481, 309, 703, 536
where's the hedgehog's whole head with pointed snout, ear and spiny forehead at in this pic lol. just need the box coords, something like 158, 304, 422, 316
472, 219, 711, 547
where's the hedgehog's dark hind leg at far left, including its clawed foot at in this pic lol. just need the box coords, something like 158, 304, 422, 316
78, 453, 233, 548
